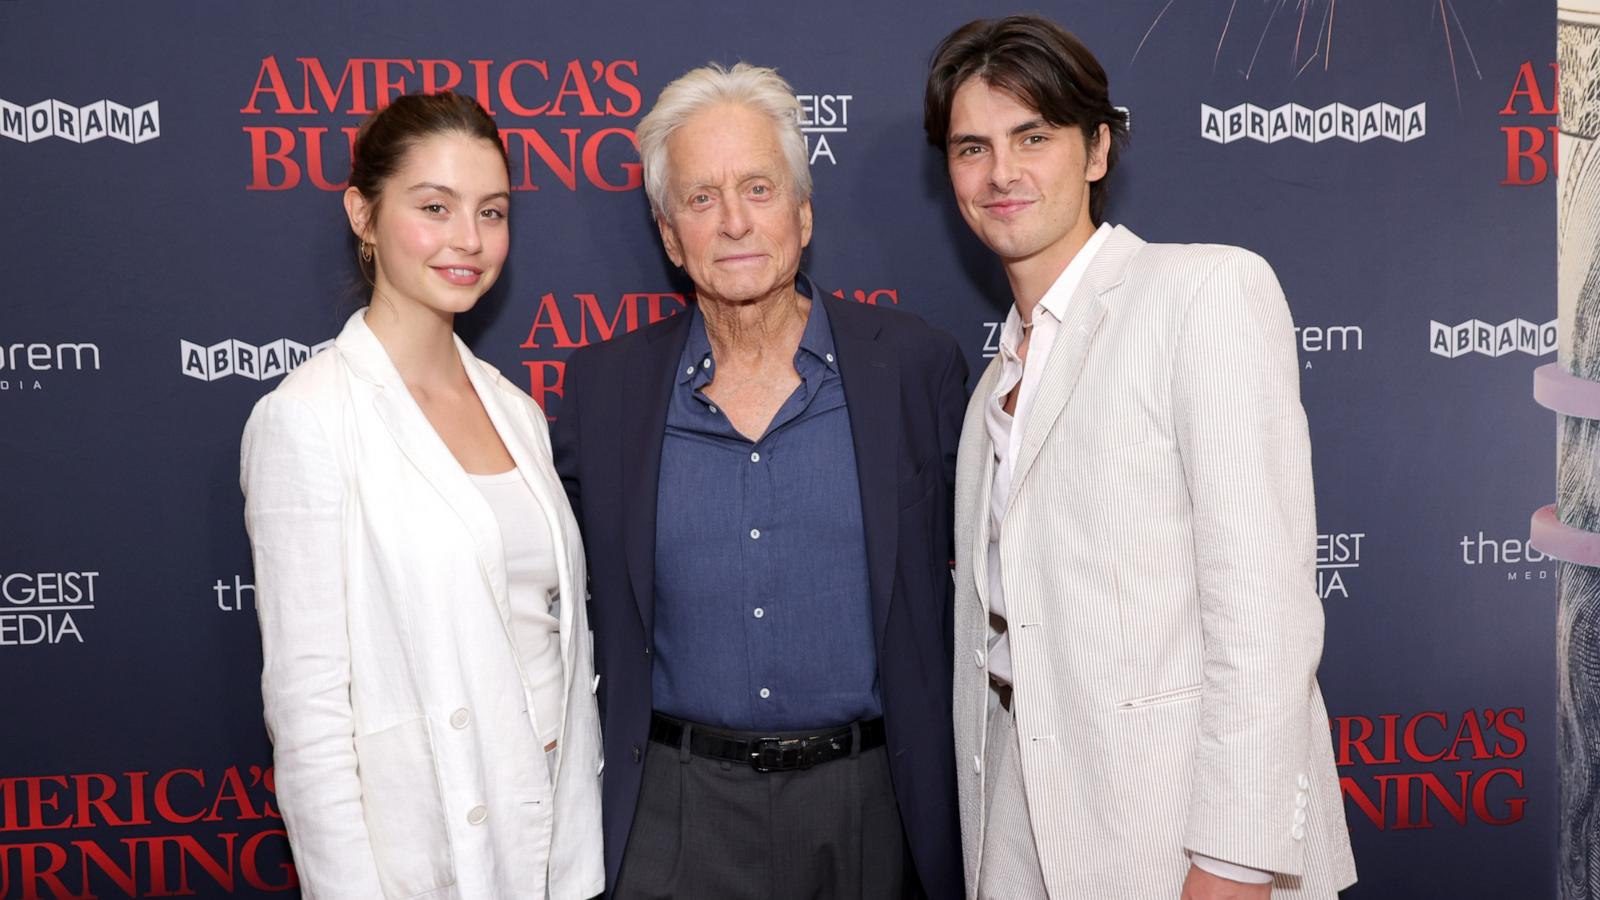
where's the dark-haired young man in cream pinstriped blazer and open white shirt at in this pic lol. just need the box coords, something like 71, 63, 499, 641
925, 16, 1355, 900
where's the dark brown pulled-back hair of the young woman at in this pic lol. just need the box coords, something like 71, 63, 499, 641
350, 91, 510, 282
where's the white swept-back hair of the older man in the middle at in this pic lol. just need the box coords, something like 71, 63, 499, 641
637, 62, 811, 219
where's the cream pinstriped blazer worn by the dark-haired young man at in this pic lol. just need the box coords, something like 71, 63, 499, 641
954, 227, 1355, 900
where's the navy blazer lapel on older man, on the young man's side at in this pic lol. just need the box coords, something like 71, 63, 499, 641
816, 291, 901, 652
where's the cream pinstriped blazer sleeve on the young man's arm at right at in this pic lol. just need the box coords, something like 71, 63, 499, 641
1173, 250, 1323, 874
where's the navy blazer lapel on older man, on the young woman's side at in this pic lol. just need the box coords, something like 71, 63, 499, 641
614, 311, 693, 641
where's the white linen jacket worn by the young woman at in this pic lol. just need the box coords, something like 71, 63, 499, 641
240, 312, 605, 900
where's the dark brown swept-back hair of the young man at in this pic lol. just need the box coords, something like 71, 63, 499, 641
922, 16, 1128, 224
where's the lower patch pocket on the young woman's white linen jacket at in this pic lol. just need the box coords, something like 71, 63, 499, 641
355, 716, 456, 898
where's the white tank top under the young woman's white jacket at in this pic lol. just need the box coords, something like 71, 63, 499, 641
470, 469, 562, 746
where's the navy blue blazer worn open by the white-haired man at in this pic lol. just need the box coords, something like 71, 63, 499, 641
550, 291, 966, 900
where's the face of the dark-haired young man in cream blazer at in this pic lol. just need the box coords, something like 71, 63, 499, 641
946, 78, 1110, 266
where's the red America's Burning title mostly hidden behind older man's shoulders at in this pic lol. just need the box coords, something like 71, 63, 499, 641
518, 288, 899, 412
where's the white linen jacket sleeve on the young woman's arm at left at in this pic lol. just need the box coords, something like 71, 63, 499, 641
240, 392, 384, 900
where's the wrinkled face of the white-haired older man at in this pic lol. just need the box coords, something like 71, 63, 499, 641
656, 106, 811, 303
